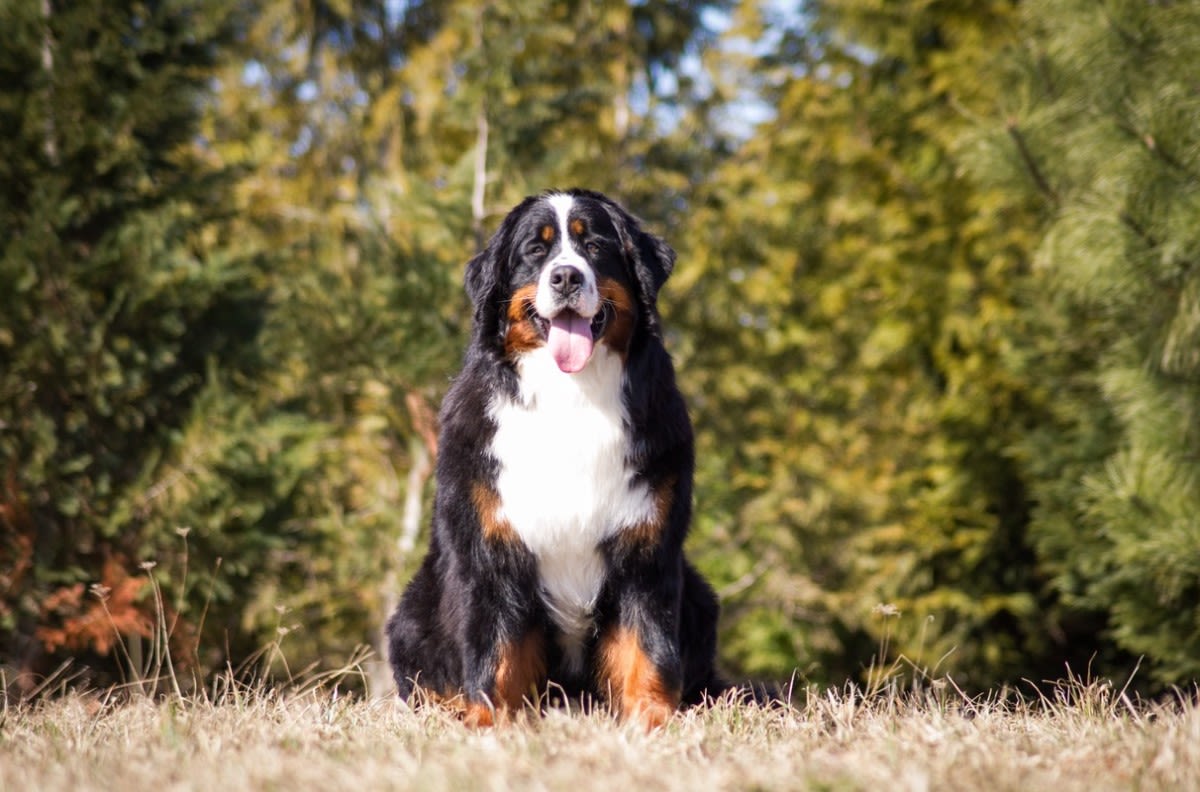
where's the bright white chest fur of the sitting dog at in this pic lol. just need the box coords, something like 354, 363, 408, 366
491, 344, 655, 668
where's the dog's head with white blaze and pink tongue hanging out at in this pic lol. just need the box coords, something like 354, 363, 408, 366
466, 190, 674, 373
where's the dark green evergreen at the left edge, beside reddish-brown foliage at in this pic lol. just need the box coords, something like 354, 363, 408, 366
0, 0, 255, 690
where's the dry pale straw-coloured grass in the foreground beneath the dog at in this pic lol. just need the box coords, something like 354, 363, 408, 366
0, 682, 1200, 792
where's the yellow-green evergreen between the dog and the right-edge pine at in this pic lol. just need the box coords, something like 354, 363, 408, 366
674, 0, 1086, 686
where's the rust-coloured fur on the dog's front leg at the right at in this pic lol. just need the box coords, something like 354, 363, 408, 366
598, 626, 679, 730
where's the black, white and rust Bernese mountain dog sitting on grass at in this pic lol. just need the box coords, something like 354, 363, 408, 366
388, 190, 725, 727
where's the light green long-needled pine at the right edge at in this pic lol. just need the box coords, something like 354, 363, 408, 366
976, 0, 1200, 683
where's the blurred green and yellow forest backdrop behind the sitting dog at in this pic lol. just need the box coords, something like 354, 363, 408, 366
0, 0, 1200, 695
